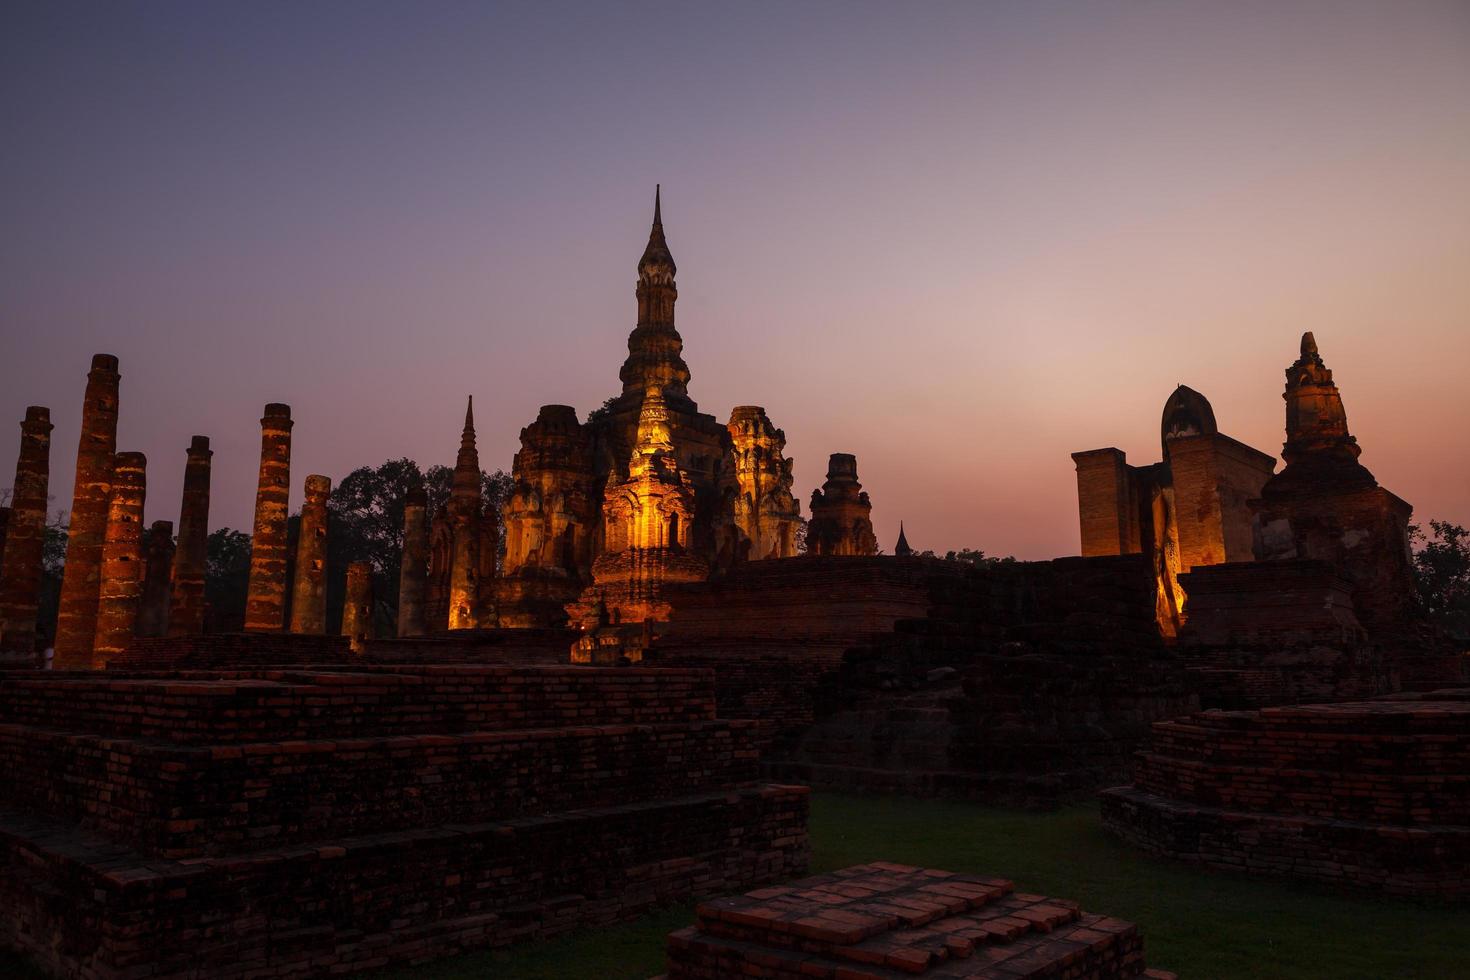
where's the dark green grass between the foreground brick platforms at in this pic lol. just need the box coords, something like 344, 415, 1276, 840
0, 793, 1470, 980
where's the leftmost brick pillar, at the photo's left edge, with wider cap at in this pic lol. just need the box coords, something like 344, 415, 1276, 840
0, 406, 51, 654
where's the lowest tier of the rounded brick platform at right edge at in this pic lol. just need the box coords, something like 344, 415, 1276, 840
1100, 786, 1470, 901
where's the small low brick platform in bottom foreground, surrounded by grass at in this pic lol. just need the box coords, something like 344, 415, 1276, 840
667, 862, 1173, 980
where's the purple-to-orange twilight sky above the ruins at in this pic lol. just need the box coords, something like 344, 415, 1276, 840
0, 0, 1470, 558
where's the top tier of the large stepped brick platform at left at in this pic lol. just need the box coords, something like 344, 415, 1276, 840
0, 666, 714, 742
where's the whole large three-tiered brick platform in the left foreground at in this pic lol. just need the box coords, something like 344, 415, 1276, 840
0, 666, 807, 979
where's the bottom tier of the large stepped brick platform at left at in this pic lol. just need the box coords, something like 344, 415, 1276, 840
0, 786, 807, 980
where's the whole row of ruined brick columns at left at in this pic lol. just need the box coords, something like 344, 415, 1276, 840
0, 354, 458, 670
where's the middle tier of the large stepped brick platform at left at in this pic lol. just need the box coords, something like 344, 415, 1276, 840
0, 721, 759, 858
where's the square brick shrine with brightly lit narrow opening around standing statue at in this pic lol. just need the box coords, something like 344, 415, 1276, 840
1072, 385, 1276, 636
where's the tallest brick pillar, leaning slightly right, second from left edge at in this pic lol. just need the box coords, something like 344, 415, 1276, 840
54, 354, 119, 670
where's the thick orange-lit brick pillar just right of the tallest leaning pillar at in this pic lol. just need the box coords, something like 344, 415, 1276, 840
90, 453, 148, 669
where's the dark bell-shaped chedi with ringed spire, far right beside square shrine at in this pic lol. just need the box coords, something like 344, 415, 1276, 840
1251, 332, 1414, 632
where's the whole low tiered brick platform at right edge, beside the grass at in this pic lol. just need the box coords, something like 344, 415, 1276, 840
1103, 691, 1470, 899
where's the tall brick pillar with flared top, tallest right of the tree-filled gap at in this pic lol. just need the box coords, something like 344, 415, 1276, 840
245, 403, 291, 630
